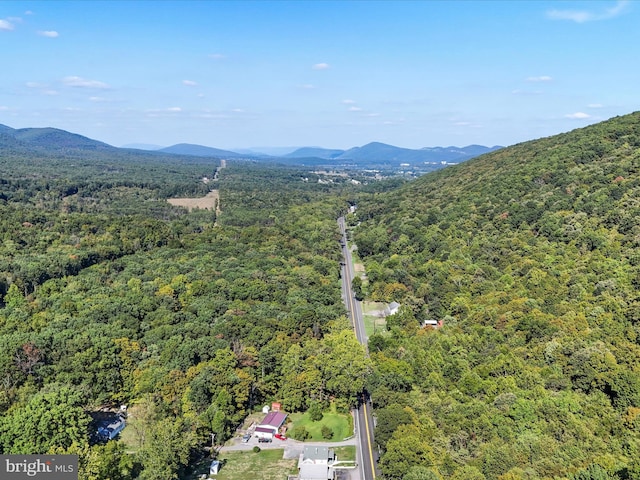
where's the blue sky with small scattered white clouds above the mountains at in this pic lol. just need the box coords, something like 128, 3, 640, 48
0, 0, 640, 148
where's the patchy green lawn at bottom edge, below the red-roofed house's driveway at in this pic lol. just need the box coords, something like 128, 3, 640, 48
184, 449, 298, 480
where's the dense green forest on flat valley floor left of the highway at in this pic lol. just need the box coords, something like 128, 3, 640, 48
0, 149, 369, 480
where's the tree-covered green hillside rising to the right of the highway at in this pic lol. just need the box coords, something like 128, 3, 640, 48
351, 113, 640, 480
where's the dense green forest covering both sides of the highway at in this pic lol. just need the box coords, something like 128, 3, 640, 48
0, 113, 640, 480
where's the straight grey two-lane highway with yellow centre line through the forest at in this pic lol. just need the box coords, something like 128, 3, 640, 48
338, 217, 377, 480
